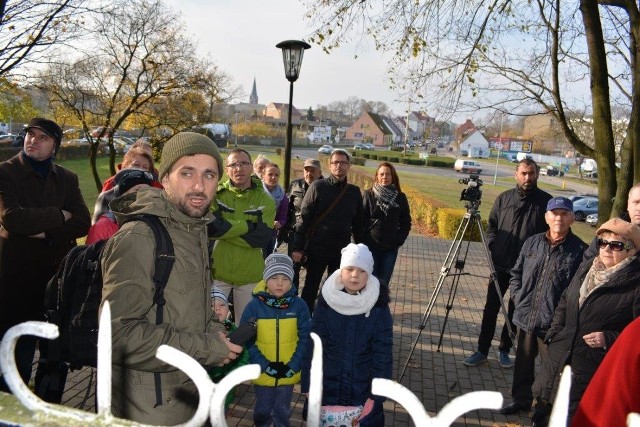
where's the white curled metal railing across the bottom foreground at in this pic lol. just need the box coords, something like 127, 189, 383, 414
0, 301, 640, 427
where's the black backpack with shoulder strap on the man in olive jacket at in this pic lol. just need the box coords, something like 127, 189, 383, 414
44, 215, 175, 370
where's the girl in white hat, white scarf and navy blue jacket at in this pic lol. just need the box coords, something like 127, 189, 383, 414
302, 243, 393, 426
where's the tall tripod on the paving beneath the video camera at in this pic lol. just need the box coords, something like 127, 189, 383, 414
398, 200, 515, 381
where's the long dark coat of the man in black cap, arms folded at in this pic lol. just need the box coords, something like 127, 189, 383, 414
0, 151, 91, 337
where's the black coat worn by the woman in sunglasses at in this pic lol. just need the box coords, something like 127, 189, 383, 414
533, 258, 640, 413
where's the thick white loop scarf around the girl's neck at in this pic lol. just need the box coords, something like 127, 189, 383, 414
321, 269, 380, 317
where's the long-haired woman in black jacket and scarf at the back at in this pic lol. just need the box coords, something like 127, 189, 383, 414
363, 162, 411, 289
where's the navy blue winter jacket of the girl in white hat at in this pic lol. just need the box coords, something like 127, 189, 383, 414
302, 292, 393, 406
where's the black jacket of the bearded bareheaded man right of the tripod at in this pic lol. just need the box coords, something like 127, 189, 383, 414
486, 187, 551, 273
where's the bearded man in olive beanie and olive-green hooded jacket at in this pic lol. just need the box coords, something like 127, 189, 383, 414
102, 132, 242, 425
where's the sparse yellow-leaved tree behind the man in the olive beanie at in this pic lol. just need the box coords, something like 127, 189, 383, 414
38, 0, 228, 188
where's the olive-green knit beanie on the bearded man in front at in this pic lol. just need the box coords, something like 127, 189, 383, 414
158, 132, 223, 181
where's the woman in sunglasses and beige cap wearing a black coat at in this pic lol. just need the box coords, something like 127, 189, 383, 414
532, 218, 640, 426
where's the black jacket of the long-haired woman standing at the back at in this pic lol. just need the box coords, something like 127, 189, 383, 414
362, 190, 411, 251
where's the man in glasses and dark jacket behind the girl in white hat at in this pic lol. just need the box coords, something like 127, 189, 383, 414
291, 149, 363, 313
